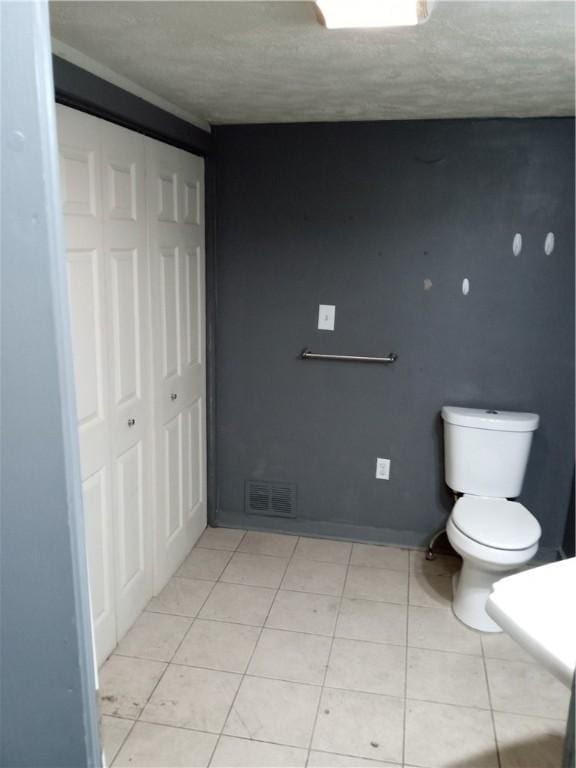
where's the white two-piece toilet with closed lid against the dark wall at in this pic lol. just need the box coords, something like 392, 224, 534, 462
442, 406, 542, 632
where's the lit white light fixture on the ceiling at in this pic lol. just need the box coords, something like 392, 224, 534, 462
316, 0, 431, 29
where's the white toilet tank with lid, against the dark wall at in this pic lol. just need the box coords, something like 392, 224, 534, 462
442, 405, 539, 499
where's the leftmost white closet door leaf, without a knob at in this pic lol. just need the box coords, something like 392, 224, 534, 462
57, 106, 116, 663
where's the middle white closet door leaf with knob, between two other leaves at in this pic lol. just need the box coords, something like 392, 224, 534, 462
102, 122, 152, 639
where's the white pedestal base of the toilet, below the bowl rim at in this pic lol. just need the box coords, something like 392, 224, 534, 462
452, 560, 514, 633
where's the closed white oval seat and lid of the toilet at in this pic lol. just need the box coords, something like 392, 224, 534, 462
451, 496, 542, 551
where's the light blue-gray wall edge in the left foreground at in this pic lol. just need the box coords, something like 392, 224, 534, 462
0, 2, 100, 768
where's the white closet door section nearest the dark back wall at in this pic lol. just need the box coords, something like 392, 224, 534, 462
147, 140, 206, 590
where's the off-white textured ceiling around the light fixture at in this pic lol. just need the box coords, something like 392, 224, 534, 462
50, 0, 574, 124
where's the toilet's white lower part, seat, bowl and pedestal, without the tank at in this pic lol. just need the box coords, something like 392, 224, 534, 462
446, 495, 541, 632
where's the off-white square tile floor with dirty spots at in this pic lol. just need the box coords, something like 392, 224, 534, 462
100, 529, 569, 768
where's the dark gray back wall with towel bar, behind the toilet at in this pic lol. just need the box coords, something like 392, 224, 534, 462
214, 119, 574, 548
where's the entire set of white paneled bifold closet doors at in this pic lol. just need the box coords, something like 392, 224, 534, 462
58, 107, 206, 662
